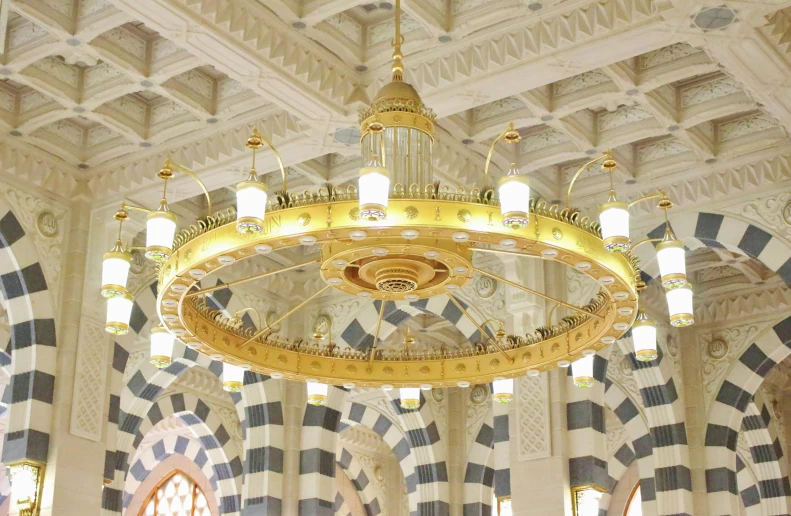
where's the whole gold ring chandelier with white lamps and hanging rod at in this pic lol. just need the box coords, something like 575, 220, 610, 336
101, 0, 694, 409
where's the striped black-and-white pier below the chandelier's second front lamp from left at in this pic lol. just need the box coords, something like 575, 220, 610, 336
298, 386, 351, 516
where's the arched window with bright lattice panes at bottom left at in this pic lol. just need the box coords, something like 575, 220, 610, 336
140, 471, 211, 516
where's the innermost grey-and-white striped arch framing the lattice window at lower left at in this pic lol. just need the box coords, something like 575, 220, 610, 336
124, 435, 224, 505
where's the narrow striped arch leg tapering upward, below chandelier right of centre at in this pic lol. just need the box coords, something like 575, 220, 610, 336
463, 409, 495, 516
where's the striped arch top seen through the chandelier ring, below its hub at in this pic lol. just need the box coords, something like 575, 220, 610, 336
338, 296, 496, 351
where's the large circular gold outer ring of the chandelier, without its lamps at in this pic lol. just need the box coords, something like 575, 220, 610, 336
157, 200, 637, 387
